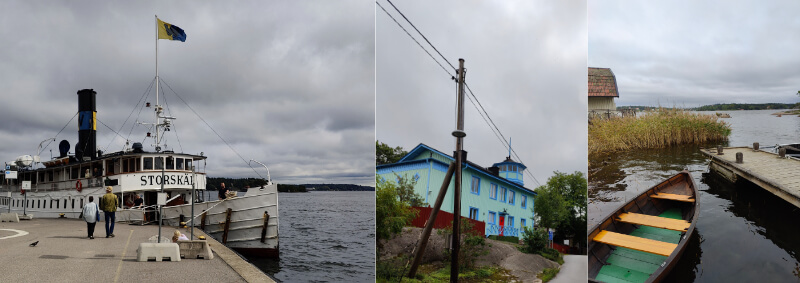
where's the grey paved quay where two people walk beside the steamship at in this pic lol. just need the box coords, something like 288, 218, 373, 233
0, 218, 274, 282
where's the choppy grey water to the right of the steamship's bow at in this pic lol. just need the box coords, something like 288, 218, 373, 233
248, 192, 375, 282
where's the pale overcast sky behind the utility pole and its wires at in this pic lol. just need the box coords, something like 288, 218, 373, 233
375, 0, 587, 188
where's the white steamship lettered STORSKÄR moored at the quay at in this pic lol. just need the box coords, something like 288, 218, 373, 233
0, 89, 278, 257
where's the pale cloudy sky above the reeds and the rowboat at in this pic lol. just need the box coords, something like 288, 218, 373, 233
589, 0, 800, 107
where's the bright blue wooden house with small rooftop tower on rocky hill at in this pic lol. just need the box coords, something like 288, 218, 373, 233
376, 144, 536, 237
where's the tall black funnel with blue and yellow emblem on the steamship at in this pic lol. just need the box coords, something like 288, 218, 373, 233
75, 89, 97, 160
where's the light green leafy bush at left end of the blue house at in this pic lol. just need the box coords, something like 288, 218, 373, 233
375, 175, 417, 244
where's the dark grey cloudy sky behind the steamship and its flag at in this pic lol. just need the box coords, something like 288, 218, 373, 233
0, 0, 375, 185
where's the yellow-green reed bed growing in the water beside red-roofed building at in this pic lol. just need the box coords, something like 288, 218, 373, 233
589, 108, 731, 154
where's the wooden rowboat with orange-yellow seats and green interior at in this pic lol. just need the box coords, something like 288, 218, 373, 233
588, 170, 699, 283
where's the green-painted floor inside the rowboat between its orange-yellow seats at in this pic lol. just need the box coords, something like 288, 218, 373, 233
595, 208, 683, 283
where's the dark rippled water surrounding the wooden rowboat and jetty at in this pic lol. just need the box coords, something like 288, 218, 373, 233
588, 110, 800, 282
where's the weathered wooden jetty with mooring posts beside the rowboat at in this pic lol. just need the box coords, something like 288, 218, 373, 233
700, 146, 800, 210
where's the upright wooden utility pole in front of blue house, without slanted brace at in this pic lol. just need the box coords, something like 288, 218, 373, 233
450, 58, 467, 282
